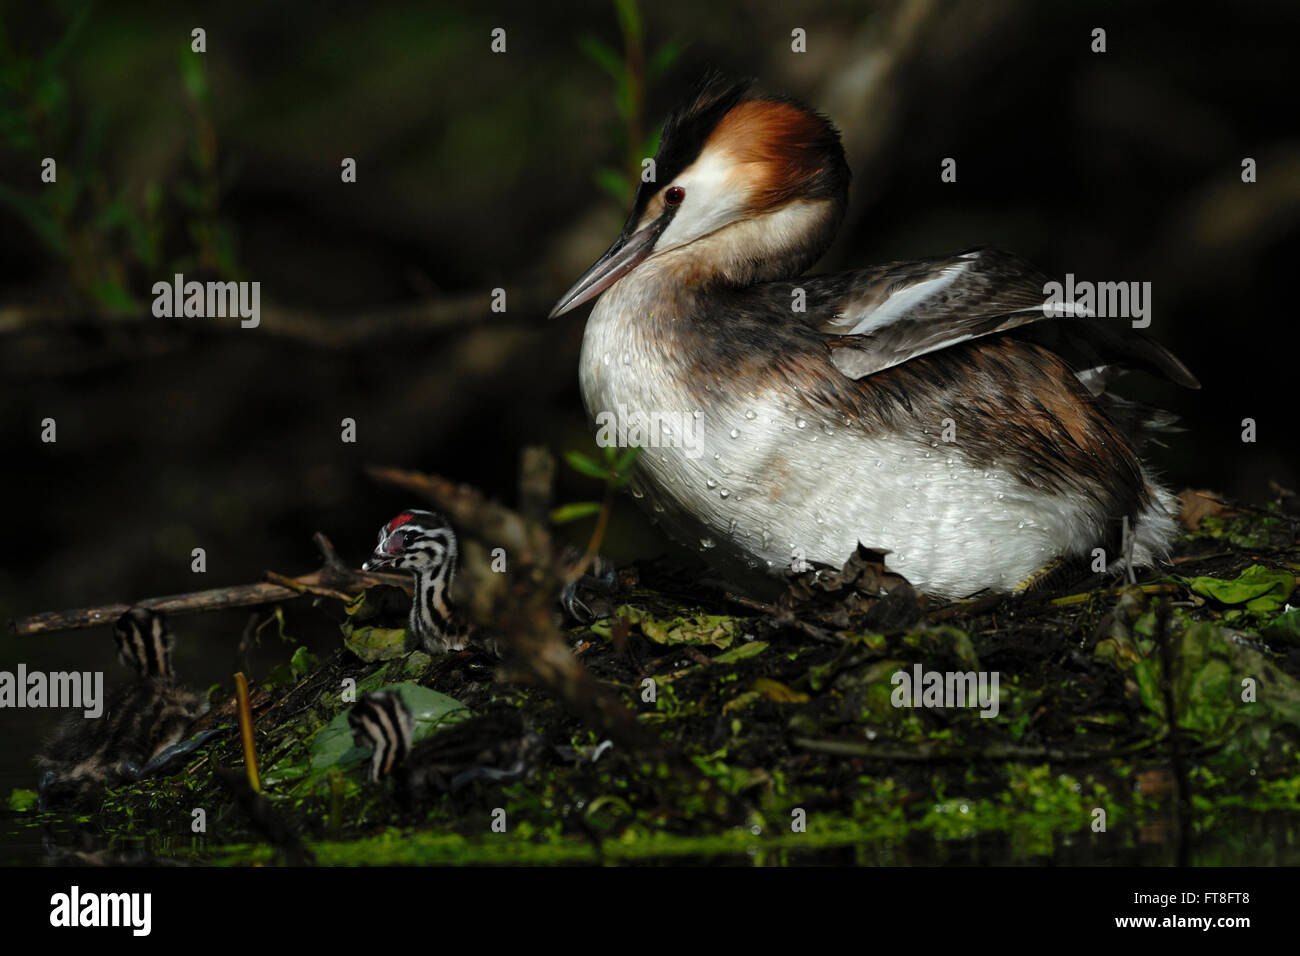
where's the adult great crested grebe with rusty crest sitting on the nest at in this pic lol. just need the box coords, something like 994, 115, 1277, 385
551, 79, 1197, 598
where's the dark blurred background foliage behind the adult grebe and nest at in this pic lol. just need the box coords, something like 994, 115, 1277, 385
0, 0, 1300, 791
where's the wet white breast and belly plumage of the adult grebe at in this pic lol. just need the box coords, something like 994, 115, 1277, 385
581, 277, 1159, 597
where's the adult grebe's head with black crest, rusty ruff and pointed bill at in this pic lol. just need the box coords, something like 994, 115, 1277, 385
551, 78, 849, 319
